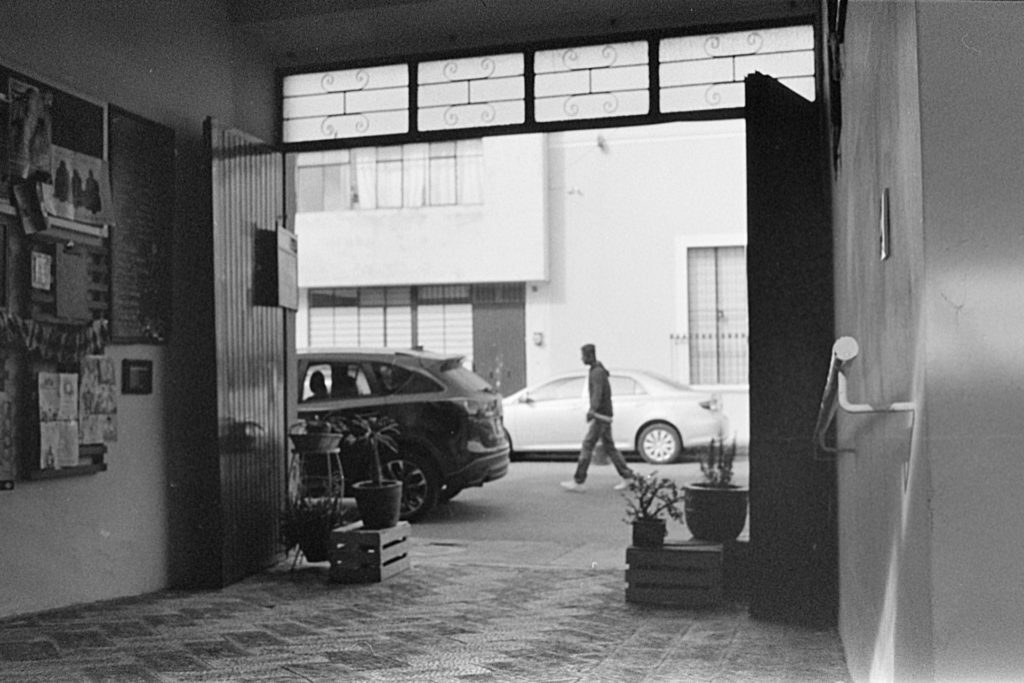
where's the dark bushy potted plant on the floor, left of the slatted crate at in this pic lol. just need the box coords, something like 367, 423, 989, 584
281, 496, 356, 567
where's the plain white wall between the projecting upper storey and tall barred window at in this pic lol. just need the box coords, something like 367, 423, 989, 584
526, 121, 746, 393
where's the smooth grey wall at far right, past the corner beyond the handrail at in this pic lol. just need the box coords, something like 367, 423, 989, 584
918, 2, 1024, 680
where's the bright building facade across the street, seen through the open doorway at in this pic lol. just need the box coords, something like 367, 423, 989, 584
295, 120, 749, 439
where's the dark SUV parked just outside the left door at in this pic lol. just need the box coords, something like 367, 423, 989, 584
298, 348, 510, 520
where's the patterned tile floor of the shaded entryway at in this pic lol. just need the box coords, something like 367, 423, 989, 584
0, 540, 849, 683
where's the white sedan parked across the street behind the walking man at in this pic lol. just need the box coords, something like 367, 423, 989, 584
504, 370, 729, 465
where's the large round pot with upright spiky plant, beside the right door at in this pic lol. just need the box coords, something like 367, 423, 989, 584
684, 438, 749, 543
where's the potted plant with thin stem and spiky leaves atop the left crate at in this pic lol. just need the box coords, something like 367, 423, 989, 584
343, 415, 401, 529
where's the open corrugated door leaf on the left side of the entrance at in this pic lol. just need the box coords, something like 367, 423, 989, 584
204, 120, 294, 584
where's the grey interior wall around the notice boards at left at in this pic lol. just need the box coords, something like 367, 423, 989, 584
0, 0, 275, 615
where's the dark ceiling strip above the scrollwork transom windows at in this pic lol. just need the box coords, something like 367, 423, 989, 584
226, 0, 819, 67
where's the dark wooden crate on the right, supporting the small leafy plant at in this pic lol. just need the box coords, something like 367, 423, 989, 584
626, 541, 723, 607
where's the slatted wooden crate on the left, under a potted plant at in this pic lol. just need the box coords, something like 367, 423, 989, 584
329, 522, 411, 584
